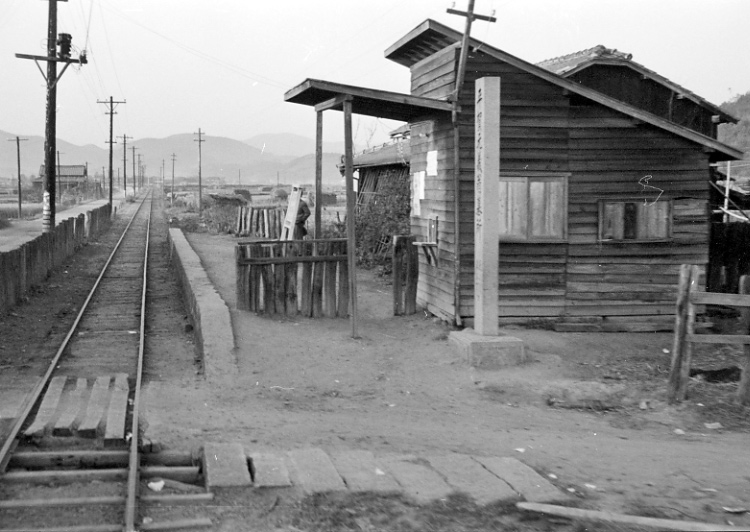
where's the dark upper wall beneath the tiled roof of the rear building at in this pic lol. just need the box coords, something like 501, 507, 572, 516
570, 65, 717, 138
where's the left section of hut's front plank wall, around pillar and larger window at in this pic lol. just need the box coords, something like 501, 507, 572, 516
460, 52, 569, 317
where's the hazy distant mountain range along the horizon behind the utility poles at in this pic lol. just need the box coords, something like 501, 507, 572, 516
0, 130, 341, 185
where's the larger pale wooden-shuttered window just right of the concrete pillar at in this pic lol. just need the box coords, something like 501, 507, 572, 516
500, 176, 568, 241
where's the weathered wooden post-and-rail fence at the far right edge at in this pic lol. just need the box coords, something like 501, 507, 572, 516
667, 264, 750, 406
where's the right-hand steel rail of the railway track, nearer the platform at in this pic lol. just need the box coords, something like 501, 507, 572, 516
125, 191, 154, 532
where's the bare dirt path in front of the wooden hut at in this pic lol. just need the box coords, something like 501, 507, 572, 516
137, 234, 750, 525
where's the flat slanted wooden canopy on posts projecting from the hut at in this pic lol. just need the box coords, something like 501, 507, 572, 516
284, 79, 453, 122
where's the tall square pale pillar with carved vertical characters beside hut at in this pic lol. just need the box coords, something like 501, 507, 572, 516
474, 77, 500, 336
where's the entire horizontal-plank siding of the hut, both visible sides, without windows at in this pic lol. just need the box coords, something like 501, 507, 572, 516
411, 47, 709, 319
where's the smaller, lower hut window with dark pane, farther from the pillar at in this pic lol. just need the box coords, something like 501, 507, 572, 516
599, 201, 672, 242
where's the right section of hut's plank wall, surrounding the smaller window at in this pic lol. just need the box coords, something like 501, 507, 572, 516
565, 98, 709, 317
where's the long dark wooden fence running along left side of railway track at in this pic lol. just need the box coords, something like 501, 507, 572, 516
0, 204, 111, 312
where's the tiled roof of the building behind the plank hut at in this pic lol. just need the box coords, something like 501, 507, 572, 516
536, 44, 739, 124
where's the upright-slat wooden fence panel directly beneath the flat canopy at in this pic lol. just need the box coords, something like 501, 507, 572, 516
235, 238, 349, 318
